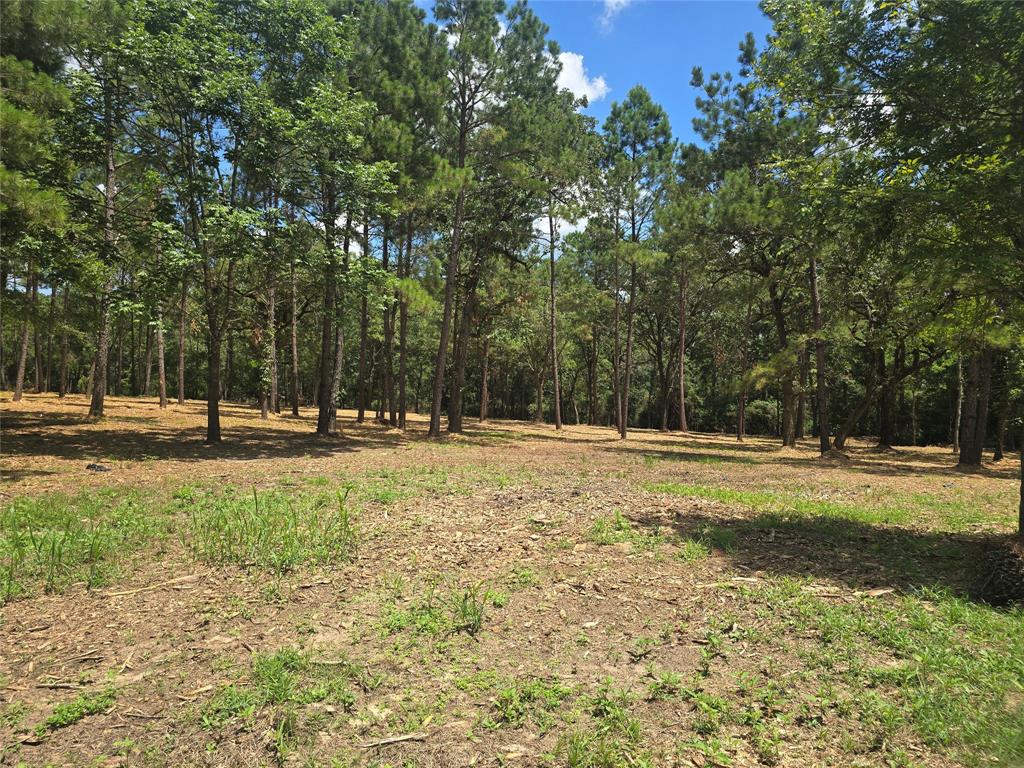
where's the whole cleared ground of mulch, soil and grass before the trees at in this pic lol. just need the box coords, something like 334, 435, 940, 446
0, 395, 1024, 768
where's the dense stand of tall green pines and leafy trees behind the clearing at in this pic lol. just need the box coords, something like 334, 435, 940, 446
0, 0, 1024, 516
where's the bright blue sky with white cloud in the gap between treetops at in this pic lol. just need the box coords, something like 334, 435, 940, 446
530, 0, 771, 141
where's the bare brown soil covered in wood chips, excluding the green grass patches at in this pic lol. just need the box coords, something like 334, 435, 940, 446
0, 394, 1017, 767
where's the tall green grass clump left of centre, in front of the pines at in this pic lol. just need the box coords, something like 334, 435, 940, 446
179, 488, 358, 573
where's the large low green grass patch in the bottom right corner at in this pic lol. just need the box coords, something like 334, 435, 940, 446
758, 583, 1024, 765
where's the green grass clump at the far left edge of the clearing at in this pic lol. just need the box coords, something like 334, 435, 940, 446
0, 490, 162, 604
